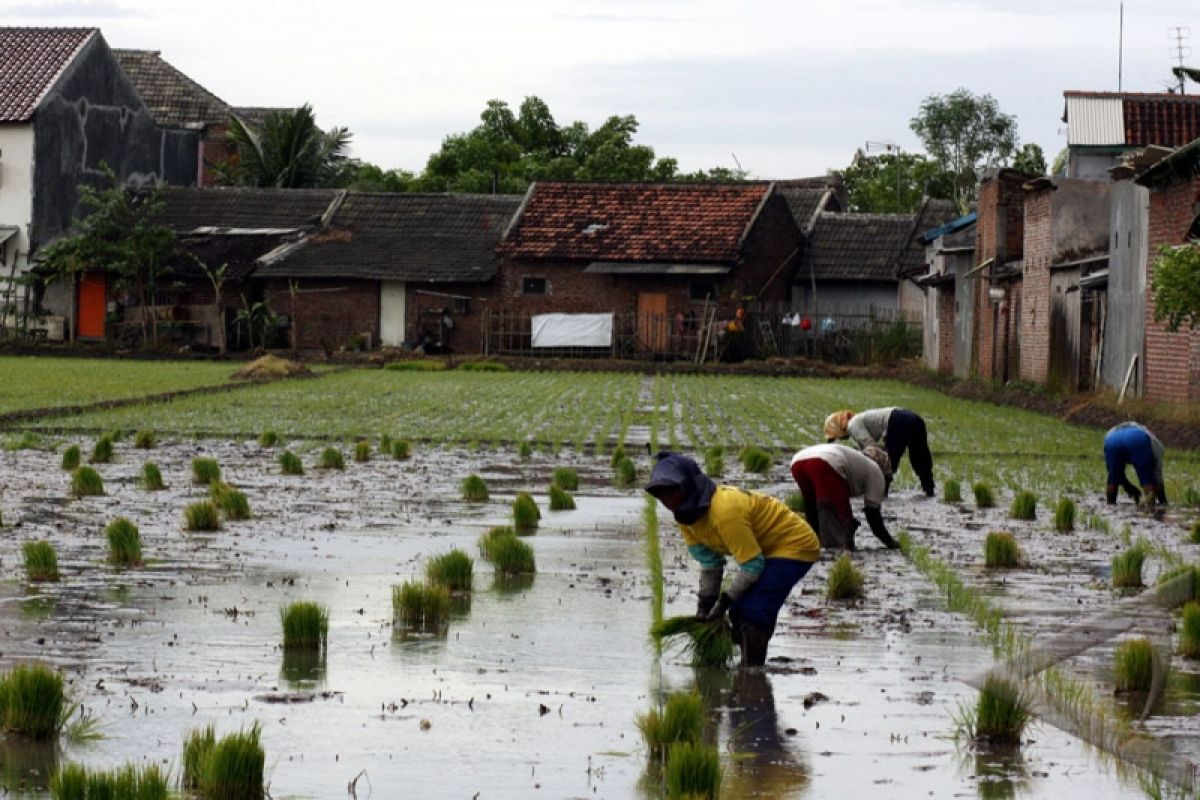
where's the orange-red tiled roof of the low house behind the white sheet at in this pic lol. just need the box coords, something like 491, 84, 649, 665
500, 182, 770, 261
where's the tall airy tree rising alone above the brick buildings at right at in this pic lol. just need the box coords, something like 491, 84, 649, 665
908, 89, 1016, 212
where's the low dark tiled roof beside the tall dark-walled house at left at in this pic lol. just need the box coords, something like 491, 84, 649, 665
158, 187, 338, 233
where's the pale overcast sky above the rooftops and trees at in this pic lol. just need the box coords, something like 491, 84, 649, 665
0, 0, 1200, 178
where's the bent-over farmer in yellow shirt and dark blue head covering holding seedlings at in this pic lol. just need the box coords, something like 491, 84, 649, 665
646, 452, 821, 667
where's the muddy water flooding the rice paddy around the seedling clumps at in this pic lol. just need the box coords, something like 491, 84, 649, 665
0, 441, 1180, 798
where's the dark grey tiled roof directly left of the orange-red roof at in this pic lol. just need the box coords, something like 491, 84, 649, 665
256, 192, 521, 282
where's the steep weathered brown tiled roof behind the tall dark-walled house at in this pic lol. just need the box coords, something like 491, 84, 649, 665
113, 49, 229, 128
